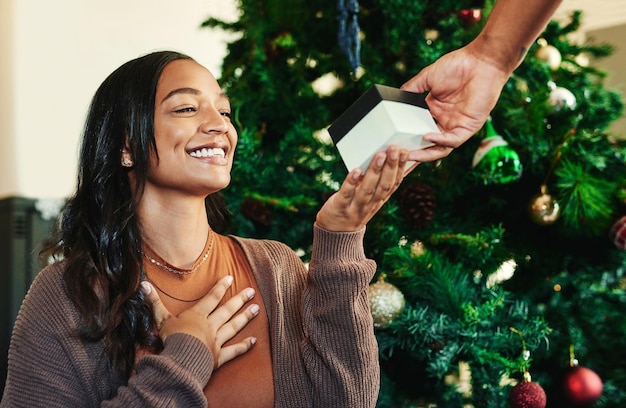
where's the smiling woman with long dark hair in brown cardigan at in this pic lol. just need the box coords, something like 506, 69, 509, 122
0, 51, 408, 408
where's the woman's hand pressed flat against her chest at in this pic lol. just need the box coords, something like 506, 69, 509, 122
142, 276, 259, 368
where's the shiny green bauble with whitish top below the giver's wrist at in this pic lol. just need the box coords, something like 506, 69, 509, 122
472, 120, 522, 184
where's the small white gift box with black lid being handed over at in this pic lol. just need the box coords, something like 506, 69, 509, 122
328, 85, 440, 171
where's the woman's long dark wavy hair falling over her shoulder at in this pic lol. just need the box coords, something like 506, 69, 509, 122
45, 51, 228, 380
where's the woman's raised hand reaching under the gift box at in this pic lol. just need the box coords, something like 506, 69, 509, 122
315, 146, 409, 232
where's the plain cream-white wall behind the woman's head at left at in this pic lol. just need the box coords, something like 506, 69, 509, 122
0, 0, 236, 198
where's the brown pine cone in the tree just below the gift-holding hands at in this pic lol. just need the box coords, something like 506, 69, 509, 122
398, 182, 437, 229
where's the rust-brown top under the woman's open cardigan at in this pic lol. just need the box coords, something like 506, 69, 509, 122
144, 232, 274, 408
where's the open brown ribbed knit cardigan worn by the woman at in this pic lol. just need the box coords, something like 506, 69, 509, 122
0, 227, 379, 408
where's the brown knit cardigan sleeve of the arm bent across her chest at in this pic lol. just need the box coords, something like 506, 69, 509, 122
0, 265, 213, 408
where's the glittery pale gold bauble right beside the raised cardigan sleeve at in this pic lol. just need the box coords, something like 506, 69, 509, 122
368, 275, 405, 329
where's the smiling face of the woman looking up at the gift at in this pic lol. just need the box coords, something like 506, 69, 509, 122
146, 60, 237, 197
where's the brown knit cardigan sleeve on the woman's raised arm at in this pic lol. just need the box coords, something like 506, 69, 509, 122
302, 226, 380, 408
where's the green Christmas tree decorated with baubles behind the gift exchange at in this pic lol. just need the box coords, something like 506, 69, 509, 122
203, 0, 626, 407
